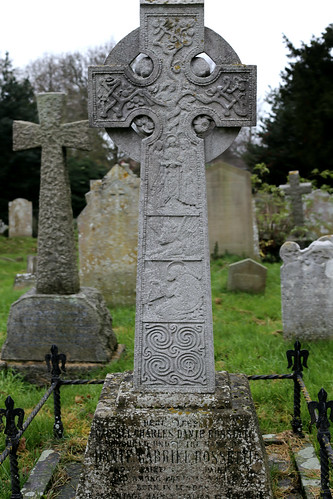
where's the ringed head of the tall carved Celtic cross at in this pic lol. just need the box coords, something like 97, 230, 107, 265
89, 0, 256, 161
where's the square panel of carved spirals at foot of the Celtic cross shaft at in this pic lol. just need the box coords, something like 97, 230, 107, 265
142, 324, 207, 386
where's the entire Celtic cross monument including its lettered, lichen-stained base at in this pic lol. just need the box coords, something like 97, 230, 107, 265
77, 0, 272, 499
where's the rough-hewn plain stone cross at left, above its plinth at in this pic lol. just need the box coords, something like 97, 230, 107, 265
13, 93, 90, 295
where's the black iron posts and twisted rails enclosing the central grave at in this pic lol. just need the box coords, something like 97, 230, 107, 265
0, 341, 333, 499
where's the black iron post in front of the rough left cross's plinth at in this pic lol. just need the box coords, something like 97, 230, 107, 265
45, 345, 66, 438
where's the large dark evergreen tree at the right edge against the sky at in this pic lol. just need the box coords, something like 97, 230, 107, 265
244, 24, 333, 187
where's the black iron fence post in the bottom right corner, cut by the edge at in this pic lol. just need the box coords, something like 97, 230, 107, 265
308, 388, 333, 499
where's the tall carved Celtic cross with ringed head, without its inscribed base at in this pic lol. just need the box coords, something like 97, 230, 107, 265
89, 0, 256, 393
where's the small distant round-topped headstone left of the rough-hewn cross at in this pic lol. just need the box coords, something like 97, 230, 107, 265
8, 198, 32, 237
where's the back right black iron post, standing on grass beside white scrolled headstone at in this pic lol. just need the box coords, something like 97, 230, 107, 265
287, 341, 309, 437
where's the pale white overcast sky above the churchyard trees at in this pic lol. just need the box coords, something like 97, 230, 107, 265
0, 0, 333, 109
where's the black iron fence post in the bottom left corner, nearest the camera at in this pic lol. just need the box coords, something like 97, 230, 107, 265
0, 396, 24, 499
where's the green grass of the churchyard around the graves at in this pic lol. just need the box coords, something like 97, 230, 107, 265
0, 237, 333, 499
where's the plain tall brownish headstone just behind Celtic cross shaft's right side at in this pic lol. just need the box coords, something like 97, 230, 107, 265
206, 163, 259, 258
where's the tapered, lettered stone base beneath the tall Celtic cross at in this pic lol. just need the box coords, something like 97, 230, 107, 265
76, 373, 273, 499
